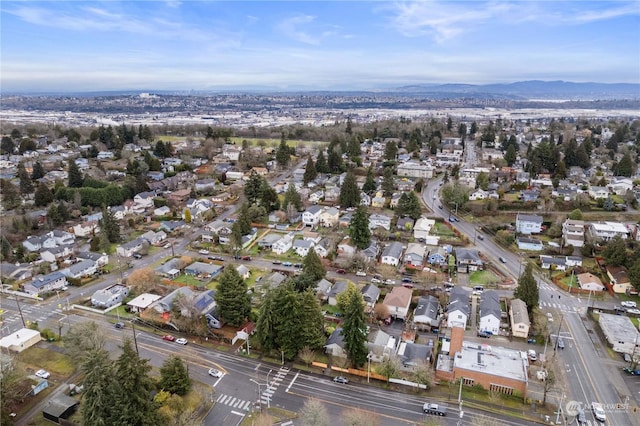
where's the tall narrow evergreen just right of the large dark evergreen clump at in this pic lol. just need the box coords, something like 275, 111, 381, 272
342, 287, 368, 367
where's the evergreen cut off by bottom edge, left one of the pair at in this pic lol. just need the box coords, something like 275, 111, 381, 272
81, 348, 115, 426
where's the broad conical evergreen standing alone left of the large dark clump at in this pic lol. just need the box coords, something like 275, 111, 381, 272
215, 268, 251, 326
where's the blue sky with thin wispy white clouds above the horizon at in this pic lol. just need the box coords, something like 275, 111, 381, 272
0, 0, 640, 92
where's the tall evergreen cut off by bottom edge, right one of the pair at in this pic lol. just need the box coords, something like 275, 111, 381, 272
112, 339, 159, 426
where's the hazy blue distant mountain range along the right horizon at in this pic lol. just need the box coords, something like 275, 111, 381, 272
388, 80, 640, 100
